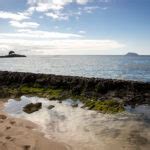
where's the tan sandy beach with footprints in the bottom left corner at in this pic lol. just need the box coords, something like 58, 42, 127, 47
0, 101, 66, 150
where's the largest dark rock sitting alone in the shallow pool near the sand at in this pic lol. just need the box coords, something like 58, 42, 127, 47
23, 103, 42, 114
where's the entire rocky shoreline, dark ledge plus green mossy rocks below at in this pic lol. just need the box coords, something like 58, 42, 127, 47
0, 71, 150, 113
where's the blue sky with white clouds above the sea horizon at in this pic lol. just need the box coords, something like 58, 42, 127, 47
0, 0, 150, 55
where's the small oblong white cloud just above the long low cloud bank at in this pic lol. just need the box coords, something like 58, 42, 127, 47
9, 21, 39, 29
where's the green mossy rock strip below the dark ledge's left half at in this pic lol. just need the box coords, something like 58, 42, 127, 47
0, 85, 70, 100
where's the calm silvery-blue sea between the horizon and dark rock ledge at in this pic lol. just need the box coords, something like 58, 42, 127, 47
0, 56, 150, 82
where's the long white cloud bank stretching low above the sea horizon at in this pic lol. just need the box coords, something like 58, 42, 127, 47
0, 29, 124, 54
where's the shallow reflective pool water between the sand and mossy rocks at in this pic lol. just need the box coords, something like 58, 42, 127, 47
4, 96, 150, 150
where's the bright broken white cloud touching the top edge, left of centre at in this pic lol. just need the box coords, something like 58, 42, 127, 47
28, 0, 91, 20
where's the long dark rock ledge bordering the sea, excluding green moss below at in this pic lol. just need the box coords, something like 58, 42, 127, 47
0, 71, 150, 105
